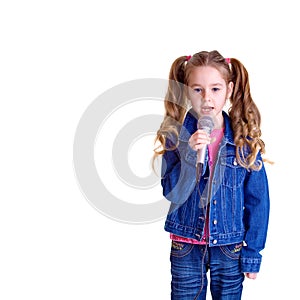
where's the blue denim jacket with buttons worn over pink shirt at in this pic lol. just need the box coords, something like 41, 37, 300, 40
161, 110, 269, 273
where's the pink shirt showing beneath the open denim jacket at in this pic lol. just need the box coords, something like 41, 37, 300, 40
170, 128, 224, 245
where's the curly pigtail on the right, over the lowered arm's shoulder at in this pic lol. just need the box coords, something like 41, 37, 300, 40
229, 58, 265, 170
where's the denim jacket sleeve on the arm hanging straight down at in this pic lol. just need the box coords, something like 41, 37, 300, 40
241, 157, 270, 273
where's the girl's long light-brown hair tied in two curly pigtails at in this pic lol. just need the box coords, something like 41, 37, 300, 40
154, 51, 265, 170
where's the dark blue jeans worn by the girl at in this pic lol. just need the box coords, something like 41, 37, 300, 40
170, 241, 244, 300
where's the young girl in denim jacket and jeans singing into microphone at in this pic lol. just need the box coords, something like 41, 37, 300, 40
155, 51, 269, 300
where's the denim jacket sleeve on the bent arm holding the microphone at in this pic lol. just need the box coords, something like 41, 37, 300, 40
161, 137, 197, 204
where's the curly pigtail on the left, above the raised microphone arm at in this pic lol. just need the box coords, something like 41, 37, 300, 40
154, 56, 188, 158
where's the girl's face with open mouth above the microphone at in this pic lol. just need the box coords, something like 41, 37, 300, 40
188, 66, 233, 126
